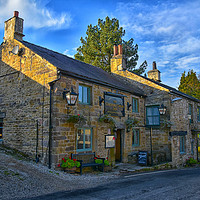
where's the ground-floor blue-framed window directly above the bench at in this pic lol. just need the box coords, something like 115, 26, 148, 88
77, 128, 92, 151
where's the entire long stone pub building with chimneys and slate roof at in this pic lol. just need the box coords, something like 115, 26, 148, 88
0, 11, 200, 167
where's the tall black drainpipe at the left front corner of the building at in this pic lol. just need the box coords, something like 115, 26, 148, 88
48, 72, 61, 169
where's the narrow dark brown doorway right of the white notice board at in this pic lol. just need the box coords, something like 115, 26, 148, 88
115, 129, 122, 162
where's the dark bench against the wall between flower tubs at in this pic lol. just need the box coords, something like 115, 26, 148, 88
71, 153, 105, 175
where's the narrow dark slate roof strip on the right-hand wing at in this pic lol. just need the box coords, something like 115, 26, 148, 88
131, 72, 200, 103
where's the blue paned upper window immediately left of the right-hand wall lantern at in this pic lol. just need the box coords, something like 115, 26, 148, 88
146, 106, 160, 126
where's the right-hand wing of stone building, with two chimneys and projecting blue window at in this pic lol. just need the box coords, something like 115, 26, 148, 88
111, 47, 200, 165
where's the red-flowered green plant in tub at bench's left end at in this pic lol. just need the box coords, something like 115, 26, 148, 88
58, 157, 81, 173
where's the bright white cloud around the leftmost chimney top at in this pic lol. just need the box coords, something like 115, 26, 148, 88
0, 0, 71, 29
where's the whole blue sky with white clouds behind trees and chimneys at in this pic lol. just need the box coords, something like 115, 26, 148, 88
0, 0, 200, 88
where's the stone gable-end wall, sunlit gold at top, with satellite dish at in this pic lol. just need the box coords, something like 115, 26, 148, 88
0, 40, 57, 164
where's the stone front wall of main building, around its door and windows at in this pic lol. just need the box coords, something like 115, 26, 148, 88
48, 76, 146, 167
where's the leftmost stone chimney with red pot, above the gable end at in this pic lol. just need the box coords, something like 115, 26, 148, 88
4, 11, 24, 42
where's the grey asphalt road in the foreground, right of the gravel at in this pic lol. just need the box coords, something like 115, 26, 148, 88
23, 168, 200, 200
